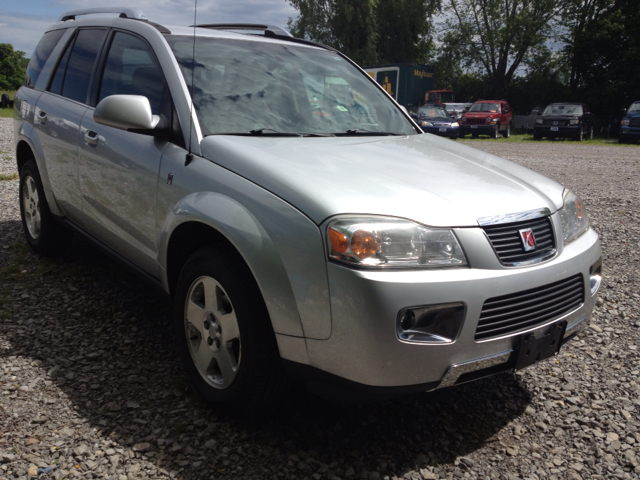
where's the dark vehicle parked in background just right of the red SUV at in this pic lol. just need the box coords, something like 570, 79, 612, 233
533, 103, 593, 142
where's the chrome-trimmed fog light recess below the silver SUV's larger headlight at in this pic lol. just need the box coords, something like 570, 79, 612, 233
396, 302, 465, 343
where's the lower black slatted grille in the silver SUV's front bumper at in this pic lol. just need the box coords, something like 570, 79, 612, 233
475, 274, 584, 340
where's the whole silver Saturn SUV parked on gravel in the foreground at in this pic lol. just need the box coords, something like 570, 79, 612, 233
14, 8, 601, 406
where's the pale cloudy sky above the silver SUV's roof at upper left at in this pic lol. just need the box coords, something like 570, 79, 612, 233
0, 0, 297, 57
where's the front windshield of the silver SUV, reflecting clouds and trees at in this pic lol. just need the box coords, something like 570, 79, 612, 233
166, 36, 416, 135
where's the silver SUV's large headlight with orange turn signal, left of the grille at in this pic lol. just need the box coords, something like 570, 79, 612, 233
327, 216, 467, 268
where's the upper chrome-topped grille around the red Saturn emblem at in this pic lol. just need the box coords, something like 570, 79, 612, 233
482, 217, 555, 265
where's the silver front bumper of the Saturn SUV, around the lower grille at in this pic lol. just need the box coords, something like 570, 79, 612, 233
306, 219, 601, 390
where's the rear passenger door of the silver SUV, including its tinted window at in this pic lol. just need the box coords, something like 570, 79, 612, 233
34, 28, 107, 219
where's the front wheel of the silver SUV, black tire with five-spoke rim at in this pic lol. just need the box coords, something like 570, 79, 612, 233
174, 245, 285, 409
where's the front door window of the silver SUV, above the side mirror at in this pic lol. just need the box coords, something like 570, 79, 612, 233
98, 32, 164, 115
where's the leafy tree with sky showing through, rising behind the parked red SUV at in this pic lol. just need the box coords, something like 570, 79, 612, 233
443, 0, 567, 98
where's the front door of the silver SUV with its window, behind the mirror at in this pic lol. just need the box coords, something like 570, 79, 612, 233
79, 31, 172, 277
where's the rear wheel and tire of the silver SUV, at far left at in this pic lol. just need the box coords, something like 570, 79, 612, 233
19, 160, 73, 255
